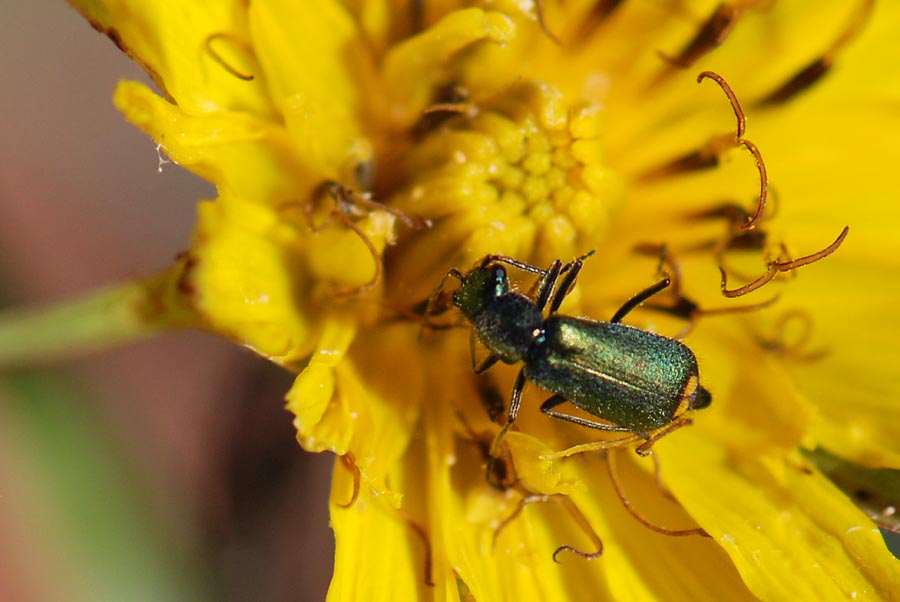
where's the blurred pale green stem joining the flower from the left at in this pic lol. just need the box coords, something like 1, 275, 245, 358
0, 278, 184, 368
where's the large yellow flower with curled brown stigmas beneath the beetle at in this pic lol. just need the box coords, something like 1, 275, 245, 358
8, 0, 900, 601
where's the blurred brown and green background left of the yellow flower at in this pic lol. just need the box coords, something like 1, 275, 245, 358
0, 0, 334, 602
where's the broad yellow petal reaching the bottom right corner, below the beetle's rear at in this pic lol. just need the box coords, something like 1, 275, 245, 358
657, 436, 900, 600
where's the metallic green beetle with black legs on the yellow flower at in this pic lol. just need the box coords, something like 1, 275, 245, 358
426, 251, 712, 453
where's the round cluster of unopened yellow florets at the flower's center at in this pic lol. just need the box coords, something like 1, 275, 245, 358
392, 83, 624, 272
